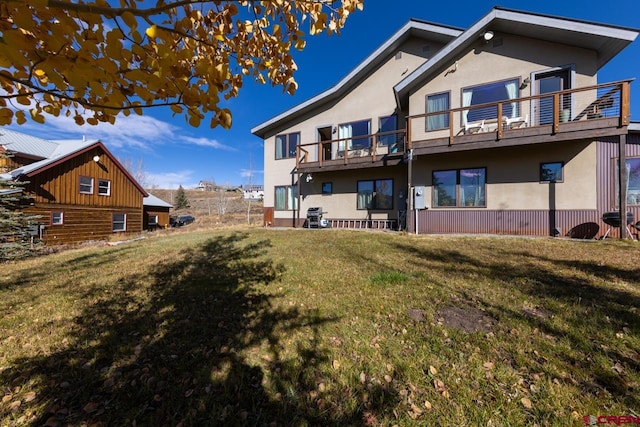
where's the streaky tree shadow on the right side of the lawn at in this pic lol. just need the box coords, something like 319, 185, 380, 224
396, 244, 640, 408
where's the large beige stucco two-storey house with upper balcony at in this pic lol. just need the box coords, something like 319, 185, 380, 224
253, 8, 640, 237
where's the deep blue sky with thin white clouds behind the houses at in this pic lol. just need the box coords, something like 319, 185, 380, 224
6, 0, 640, 188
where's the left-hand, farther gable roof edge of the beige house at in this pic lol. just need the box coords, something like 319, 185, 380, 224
251, 19, 462, 138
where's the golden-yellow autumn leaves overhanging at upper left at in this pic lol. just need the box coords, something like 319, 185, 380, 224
0, 0, 364, 128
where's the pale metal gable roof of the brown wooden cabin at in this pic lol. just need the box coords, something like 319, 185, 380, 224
0, 129, 147, 196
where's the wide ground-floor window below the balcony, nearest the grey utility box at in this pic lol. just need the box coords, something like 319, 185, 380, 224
433, 168, 487, 207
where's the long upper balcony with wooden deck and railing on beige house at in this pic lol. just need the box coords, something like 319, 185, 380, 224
296, 80, 631, 172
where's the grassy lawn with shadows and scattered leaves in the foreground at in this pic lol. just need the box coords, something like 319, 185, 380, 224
0, 229, 640, 426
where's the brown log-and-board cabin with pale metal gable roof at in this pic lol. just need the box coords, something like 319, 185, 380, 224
0, 130, 147, 244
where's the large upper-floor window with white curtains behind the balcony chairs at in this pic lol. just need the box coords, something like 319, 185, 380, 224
462, 78, 520, 124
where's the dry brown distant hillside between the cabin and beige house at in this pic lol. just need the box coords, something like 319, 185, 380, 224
147, 189, 263, 226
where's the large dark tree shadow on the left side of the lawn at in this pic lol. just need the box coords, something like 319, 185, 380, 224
0, 233, 395, 426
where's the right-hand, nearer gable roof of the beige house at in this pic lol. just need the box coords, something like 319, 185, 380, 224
393, 7, 639, 108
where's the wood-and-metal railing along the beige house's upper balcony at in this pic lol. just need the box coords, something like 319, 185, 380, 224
296, 80, 632, 167
